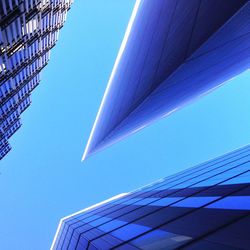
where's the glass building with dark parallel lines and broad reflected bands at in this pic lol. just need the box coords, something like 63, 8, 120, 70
51, 145, 250, 250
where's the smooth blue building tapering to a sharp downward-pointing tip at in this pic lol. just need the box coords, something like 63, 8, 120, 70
83, 0, 250, 159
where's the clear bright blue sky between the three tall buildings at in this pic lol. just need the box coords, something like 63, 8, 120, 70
0, 0, 250, 250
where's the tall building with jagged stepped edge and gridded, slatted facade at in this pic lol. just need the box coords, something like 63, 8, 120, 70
0, 0, 73, 159
